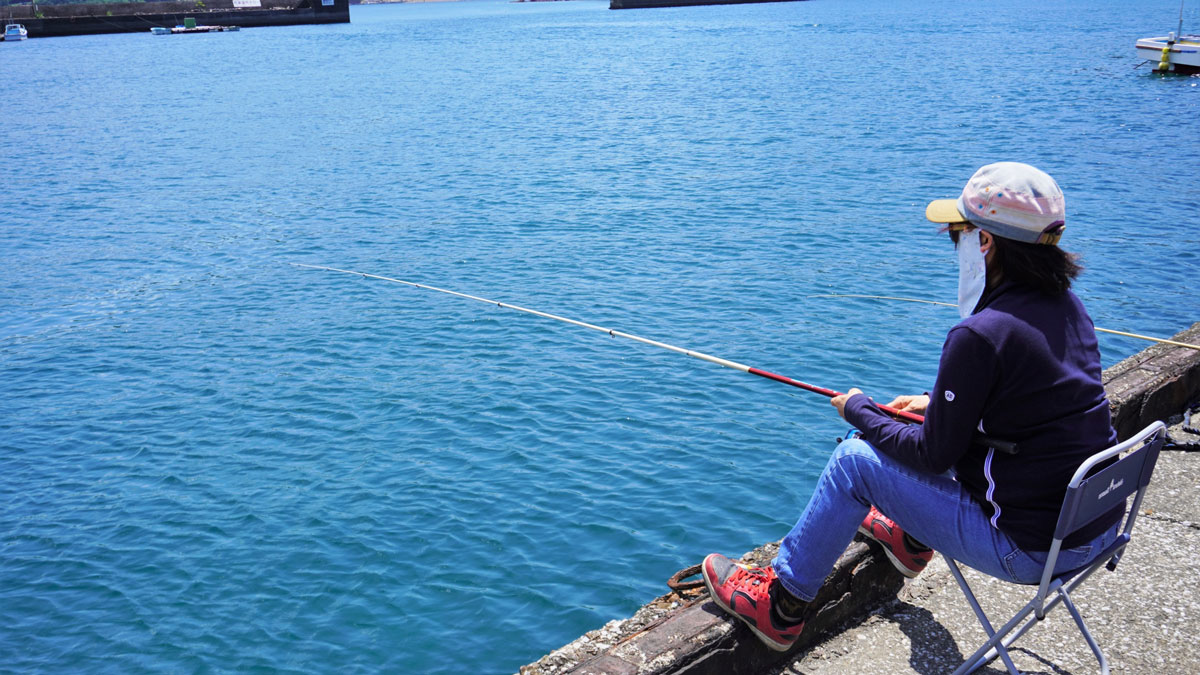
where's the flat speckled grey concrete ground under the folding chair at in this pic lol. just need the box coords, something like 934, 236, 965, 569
774, 452, 1200, 675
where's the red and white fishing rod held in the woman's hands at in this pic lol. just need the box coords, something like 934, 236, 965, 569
289, 263, 1016, 454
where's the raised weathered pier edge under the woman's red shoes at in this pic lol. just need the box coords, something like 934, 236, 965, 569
520, 322, 1200, 675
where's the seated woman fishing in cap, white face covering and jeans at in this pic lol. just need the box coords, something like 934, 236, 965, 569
703, 162, 1121, 651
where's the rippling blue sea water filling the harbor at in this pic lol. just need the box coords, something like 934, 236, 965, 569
0, 0, 1200, 674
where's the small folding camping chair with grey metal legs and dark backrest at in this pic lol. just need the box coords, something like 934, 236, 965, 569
943, 422, 1166, 675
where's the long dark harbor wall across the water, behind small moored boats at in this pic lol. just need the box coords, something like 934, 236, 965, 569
5, 0, 350, 37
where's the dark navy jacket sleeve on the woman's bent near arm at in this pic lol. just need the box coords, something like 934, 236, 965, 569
846, 325, 997, 473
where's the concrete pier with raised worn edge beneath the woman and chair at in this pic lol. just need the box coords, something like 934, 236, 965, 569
521, 323, 1200, 675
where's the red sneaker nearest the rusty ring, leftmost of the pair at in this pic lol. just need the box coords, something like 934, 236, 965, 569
701, 554, 804, 651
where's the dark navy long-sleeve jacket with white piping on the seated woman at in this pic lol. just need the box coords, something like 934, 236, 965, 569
845, 283, 1120, 551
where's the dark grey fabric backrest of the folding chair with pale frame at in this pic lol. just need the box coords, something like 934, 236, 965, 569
1054, 422, 1166, 540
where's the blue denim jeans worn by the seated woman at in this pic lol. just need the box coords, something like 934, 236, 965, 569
772, 438, 1118, 601
